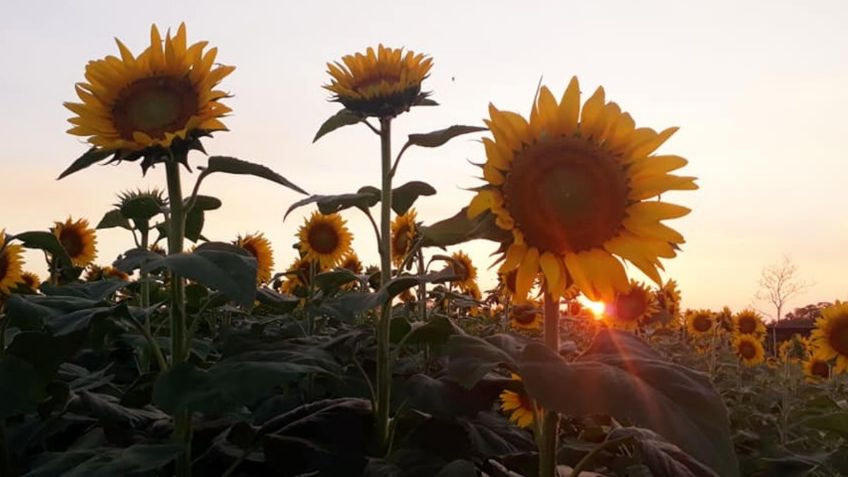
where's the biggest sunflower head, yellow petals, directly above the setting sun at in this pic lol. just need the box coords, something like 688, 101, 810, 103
468, 78, 697, 301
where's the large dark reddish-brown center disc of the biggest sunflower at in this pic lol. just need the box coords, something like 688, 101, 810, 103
503, 137, 628, 255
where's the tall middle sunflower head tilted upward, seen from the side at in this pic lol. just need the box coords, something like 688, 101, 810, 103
324, 45, 433, 117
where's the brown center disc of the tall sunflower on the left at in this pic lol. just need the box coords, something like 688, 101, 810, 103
112, 76, 197, 139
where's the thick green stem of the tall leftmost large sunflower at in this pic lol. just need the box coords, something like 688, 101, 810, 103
165, 155, 191, 477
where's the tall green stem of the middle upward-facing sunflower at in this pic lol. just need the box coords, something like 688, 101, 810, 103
376, 117, 392, 452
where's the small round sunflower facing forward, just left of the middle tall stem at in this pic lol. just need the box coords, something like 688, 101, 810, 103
298, 212, 351, 269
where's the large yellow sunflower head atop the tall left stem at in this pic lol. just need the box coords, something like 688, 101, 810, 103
65, 24, 235, 152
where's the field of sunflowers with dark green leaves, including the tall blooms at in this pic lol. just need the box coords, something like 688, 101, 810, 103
0, 25, 848, 477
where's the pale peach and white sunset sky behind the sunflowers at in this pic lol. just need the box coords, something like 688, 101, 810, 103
0, 0, 848, 318
